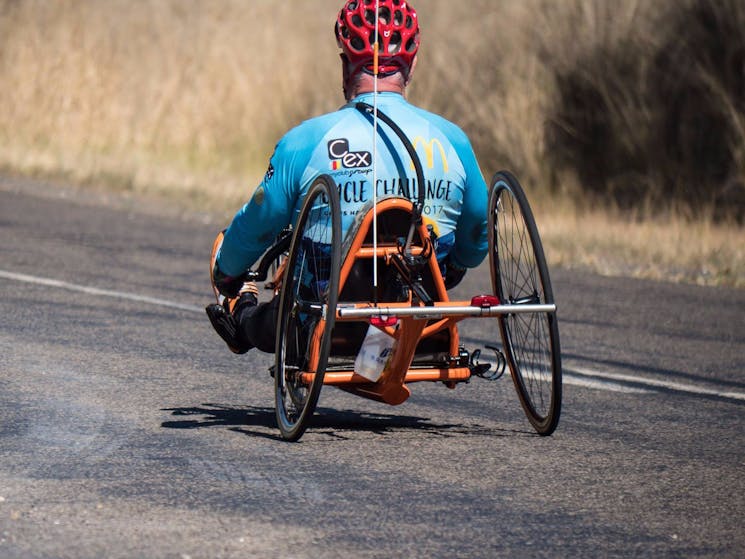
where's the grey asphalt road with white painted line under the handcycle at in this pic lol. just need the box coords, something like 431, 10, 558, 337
0, 179, 745, 559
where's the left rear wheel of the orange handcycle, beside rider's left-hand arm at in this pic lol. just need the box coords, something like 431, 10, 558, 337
274, 175, 341, 441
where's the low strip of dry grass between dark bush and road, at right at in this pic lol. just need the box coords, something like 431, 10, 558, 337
536, 199, 745, 288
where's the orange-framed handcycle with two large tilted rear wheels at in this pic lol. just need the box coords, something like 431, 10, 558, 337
213, 106, 562, 441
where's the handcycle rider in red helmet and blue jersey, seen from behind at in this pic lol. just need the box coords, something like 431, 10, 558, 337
206, 0, 487, 353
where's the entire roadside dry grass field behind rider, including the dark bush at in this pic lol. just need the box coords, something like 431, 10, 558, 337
0, 0, 745, 287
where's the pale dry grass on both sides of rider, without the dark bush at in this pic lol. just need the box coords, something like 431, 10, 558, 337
0, 0, 745, 286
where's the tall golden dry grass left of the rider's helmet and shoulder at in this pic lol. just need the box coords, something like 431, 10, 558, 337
0, 0, 338, 203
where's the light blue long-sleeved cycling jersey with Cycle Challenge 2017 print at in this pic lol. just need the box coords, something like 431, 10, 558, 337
217, 92, 487, 276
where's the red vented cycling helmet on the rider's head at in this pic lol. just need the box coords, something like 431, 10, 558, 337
336, 0, 419, 77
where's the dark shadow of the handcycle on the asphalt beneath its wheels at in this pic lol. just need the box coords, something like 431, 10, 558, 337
161, 404, 537, 439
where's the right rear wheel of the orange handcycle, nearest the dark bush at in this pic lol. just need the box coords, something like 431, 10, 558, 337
489, 171, 561, 435
